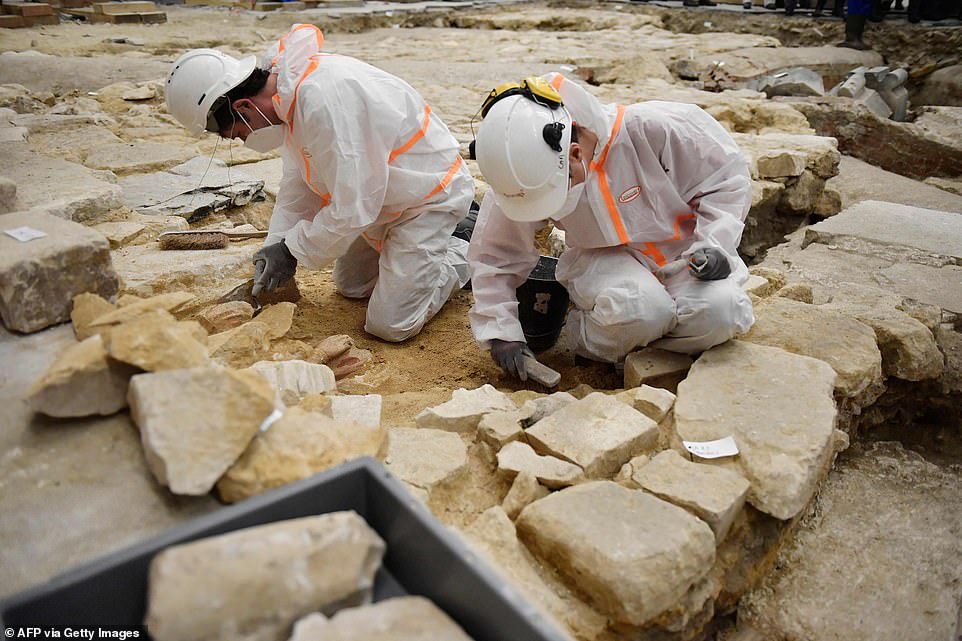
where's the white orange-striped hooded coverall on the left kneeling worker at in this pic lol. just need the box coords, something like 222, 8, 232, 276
261, 24, 474, 341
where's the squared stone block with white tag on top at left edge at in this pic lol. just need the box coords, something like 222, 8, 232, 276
0, 212, 120, 332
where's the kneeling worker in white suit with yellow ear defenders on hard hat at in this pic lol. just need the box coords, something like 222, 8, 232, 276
468, 74, 754, 379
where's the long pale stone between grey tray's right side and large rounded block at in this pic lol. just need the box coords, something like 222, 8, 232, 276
464, 505, 608, 639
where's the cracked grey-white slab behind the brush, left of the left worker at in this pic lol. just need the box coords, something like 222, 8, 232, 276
119, 156, 264, 222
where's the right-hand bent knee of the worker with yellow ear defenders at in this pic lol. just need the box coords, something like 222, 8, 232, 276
654, 278, 755, 354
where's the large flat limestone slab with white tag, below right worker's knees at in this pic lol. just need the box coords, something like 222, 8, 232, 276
675, 340, 836, 519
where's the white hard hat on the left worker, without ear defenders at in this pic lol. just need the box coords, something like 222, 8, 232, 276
166, 49, 257, 135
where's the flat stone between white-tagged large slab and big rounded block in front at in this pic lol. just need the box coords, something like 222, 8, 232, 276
631, 450, 749, 541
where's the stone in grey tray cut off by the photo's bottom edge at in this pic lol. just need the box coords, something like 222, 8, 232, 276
290, 596, 471, 641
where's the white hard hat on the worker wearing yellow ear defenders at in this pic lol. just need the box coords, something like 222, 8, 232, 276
475, 96, 571, 222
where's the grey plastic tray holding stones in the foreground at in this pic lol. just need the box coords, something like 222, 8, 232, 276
0, 458, 571, 641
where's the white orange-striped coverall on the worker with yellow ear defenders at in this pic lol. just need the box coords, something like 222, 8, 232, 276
468, 73, 755, 362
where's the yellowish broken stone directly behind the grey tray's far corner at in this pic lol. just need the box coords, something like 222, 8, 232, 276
217, 408, 385, 503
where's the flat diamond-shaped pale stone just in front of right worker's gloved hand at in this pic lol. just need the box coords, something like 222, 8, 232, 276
526, 392, 658, 478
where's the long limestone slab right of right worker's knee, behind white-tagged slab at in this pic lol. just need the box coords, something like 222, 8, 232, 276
741, 297, 882, 397
